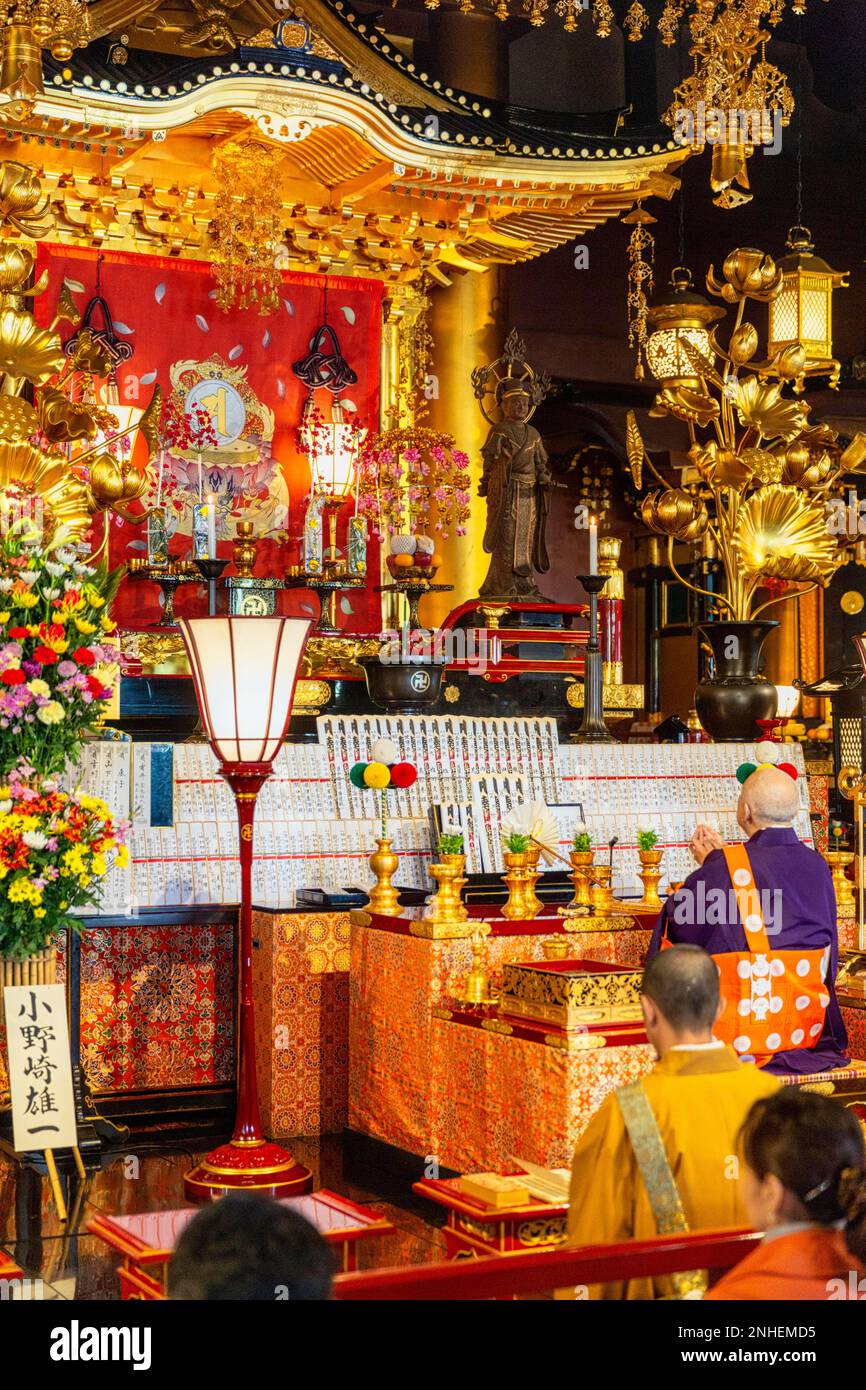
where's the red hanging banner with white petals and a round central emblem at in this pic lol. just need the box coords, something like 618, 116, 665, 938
35, 243, 382, 632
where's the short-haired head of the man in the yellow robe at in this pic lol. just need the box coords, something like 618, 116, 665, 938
641, 945, 722, 1056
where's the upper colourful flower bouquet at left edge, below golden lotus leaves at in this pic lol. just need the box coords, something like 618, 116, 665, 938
0, 511, 121, 776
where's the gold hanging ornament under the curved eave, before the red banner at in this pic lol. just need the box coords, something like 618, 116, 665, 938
211, 139, 284, 314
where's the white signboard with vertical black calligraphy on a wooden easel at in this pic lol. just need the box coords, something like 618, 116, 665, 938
3, 984, 78, 1154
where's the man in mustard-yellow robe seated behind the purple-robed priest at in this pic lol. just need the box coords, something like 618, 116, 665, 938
569, 945, 778, 1298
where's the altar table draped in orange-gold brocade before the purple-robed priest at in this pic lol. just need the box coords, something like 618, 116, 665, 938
349, 908, 655, 1170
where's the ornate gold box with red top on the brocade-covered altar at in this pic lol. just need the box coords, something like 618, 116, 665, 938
499, 960, 641, 1029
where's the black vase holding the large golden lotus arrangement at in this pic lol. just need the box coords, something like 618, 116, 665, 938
695, 621, 778, 744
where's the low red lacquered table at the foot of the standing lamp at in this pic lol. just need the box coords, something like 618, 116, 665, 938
88, 1187, 395, 1301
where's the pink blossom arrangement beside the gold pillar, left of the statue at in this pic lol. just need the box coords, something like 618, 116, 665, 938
359, 424, 471, 541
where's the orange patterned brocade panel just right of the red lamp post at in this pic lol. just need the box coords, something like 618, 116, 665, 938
253, 912, 349, 1137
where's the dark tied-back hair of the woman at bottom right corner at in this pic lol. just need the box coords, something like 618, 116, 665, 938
740, 1086, 866, 1262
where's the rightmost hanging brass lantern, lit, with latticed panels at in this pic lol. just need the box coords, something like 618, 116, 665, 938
767, 227, 848, 391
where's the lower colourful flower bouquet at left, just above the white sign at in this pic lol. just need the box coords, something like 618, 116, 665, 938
0, 762, 129, 959
